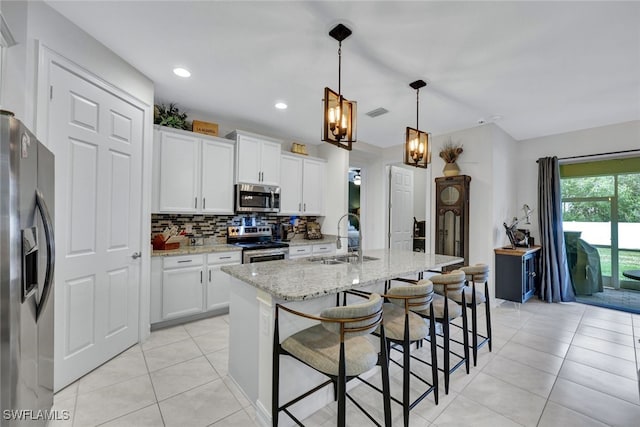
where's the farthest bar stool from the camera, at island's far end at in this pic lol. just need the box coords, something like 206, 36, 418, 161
460, 264, 492, 366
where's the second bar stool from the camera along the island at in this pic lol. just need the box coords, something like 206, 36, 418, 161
345, 284, 438, 427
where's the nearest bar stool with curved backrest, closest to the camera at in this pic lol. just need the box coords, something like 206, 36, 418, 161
271, 294, 391, 427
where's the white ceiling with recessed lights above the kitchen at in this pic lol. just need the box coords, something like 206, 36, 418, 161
48, 1, 640, 147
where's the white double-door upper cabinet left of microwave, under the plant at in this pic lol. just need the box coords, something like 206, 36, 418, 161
153, 127, 234, 214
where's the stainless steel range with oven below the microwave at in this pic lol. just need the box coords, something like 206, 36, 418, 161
227, 225, 289, 264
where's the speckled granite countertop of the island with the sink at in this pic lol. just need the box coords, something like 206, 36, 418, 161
221, 249, 463, 301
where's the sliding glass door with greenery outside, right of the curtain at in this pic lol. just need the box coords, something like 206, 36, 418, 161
560, 158, 640, 310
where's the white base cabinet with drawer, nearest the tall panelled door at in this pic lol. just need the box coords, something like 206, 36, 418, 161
162, 255, 204, 320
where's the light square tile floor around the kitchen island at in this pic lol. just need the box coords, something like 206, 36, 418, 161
50, 300, 640, 427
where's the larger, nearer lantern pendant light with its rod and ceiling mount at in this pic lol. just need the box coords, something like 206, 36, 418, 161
322, 24, 356, 151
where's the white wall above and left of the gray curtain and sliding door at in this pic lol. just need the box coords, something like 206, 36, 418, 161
514, 120, 640, 243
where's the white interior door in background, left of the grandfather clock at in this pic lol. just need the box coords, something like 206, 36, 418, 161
389, 166, 413, 251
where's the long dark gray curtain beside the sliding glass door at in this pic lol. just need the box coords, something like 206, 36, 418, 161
538, 157, 576, 302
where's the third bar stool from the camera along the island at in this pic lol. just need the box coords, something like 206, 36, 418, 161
392, 278, 469, 394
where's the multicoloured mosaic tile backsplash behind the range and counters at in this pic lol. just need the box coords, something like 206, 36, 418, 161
151, 214, 317, 241
